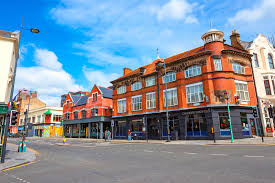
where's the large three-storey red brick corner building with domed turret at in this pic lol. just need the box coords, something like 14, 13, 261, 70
111, 29, 257, 139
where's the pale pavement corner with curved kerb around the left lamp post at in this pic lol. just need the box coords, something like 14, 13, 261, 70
0, 143, 36, 171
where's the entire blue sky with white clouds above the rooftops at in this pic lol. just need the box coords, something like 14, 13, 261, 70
0, 0, 275, 105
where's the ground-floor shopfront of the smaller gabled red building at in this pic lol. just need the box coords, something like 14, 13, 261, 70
63, 116, 111, 139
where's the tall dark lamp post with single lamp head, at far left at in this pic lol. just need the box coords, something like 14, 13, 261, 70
1, 20, 40, 163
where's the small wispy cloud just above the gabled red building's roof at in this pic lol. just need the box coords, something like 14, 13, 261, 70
83, 67, 120, 87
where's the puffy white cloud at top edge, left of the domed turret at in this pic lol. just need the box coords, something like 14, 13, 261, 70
157, 0, 198, 23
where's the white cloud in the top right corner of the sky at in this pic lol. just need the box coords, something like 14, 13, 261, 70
228, 0, 275, 24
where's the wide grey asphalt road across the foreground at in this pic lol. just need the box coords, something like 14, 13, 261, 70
0, 139, 275, 183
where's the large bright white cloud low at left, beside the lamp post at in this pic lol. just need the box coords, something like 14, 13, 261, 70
15, 49, 83, 106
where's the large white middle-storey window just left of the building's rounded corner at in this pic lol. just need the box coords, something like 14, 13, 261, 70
185, 82, 204, 104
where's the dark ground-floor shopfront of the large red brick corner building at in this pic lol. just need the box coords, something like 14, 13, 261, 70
113, 106, 260, 140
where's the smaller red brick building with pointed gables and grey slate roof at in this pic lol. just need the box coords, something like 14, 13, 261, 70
63, 85, 113, 138
